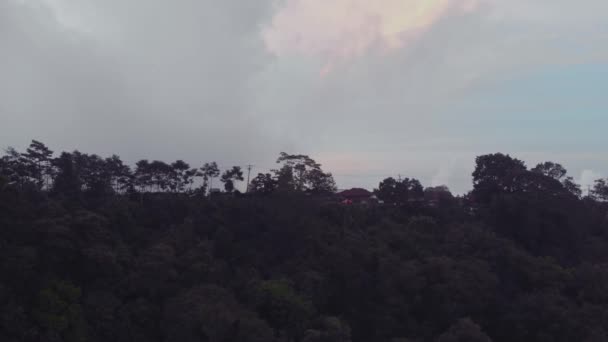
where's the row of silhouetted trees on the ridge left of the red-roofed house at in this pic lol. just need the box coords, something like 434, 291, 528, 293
0, 140, 336, 196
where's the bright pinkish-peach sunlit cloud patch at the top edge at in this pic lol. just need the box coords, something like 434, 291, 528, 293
263, 0, 477, 65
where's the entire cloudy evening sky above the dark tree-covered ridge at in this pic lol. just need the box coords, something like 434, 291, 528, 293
0, 0, 608, 193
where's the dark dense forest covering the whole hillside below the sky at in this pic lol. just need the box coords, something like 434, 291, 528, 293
0, 140, 608, 342
